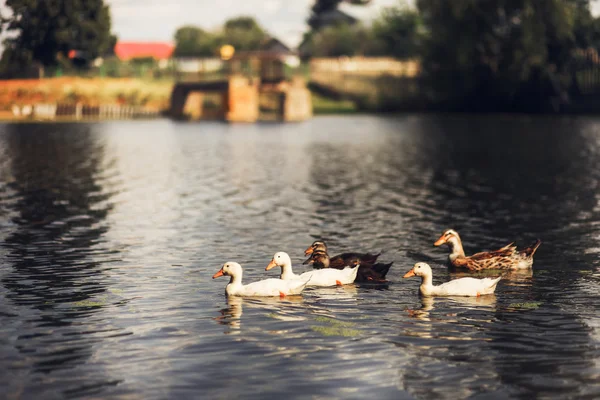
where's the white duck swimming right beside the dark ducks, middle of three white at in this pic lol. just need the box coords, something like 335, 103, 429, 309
265, 251, 359, 286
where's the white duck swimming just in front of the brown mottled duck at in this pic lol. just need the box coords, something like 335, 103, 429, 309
404, 263, 502, 296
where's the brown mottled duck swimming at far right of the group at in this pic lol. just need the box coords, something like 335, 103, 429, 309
433, 229, 542, 271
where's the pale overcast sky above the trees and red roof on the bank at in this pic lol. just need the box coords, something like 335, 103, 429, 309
0, 0, 600, 46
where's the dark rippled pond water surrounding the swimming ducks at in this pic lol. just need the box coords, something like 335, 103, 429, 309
0, 115, 600, 399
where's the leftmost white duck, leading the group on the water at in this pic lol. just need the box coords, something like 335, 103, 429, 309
213, 261, 308, 297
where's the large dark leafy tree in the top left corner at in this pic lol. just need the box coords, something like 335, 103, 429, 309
5, 0, 111, 66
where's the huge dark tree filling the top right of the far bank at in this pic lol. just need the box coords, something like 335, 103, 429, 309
417, 0, 589, 108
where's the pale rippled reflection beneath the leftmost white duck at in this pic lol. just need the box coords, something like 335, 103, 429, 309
214, 296, 305, 335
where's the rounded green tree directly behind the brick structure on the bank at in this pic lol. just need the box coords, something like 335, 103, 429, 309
220, 16, 268, 51
